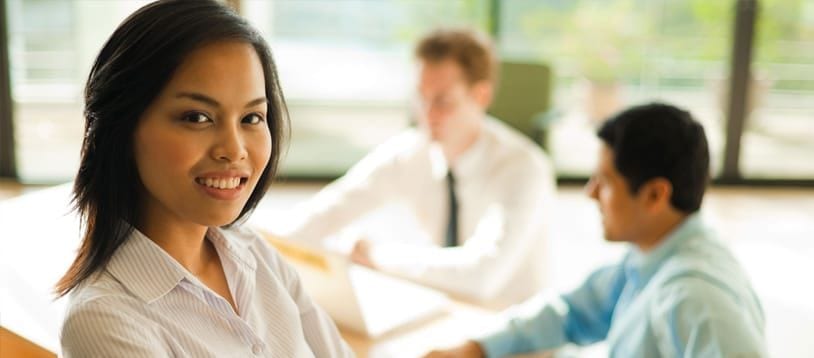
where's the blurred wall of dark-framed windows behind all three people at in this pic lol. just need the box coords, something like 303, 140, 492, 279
0, 0, 814, 184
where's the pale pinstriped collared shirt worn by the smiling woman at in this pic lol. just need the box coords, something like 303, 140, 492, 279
61, 228, 353, 357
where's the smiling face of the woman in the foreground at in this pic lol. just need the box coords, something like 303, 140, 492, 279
134, 42, 271, 226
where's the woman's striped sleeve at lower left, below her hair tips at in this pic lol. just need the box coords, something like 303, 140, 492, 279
60, 299, 172, 358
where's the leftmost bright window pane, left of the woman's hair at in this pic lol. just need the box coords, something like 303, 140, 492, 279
6, 0, 152, 182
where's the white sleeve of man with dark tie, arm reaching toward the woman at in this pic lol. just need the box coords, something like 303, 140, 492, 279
274, 136, 413, 245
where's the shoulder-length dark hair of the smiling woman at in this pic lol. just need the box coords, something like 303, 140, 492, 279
55, 0, 288, 296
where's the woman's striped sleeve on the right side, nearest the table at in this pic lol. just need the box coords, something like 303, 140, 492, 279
272, 242, 354, 357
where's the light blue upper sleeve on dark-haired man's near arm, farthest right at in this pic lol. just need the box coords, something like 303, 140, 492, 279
651, 277, 768, 357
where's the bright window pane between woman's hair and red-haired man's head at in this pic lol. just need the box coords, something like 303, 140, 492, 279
242, 0, 488, 177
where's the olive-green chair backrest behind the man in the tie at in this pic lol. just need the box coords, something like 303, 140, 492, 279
488, 61, 552, 143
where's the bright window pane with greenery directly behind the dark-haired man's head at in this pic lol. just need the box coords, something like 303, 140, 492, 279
500, 0, 734, 177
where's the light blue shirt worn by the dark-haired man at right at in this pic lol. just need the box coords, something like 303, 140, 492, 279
479, 214, 767, 357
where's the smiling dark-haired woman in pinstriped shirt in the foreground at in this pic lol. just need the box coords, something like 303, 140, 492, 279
56, 0, 352, 357
